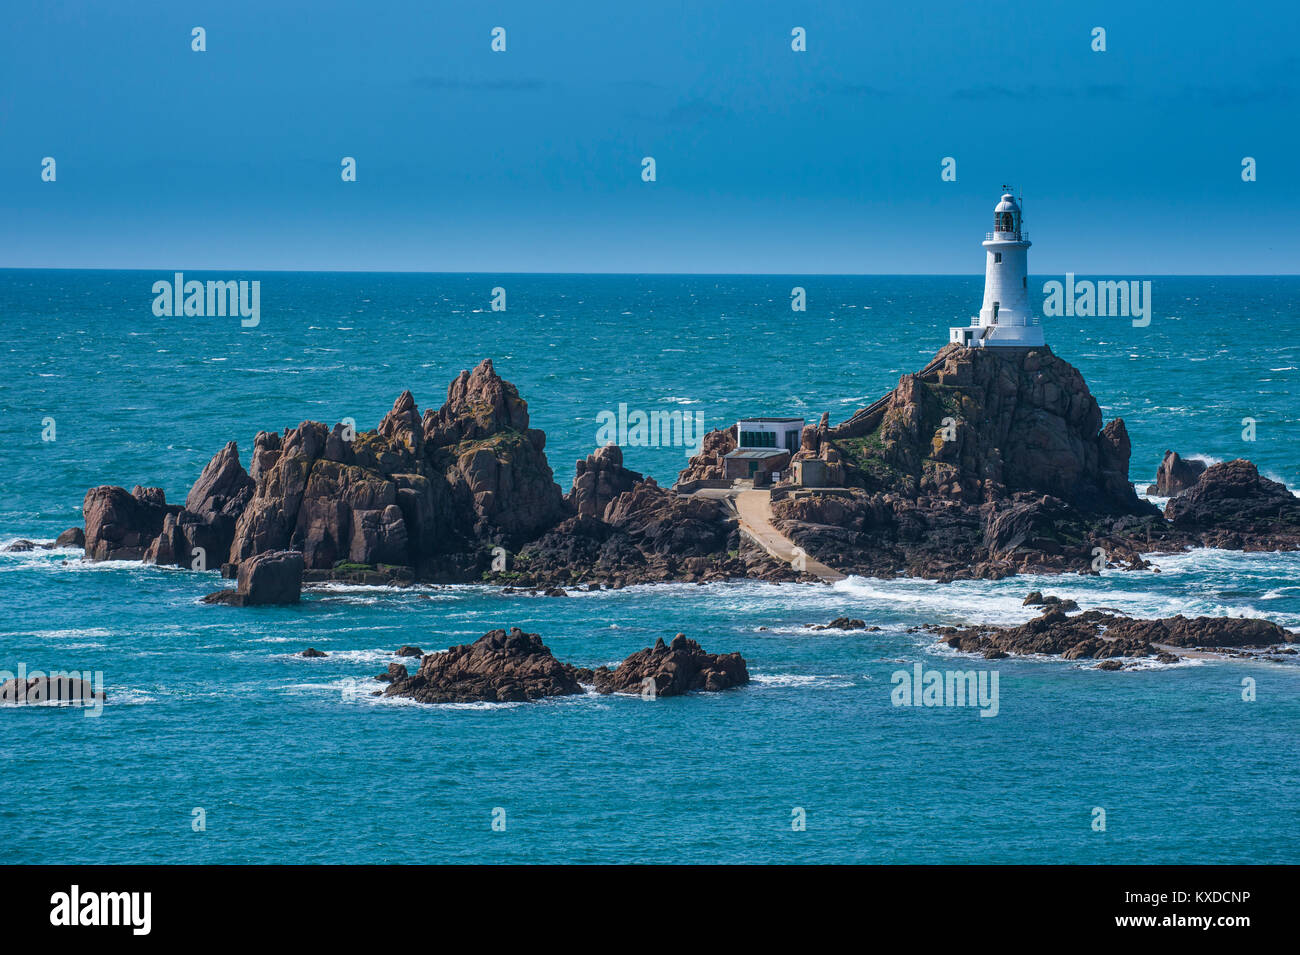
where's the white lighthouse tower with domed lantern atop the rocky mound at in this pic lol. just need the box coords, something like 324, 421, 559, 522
948, 192, 1044, 348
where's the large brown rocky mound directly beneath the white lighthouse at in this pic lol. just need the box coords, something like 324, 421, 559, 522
772, 346, 1158, 579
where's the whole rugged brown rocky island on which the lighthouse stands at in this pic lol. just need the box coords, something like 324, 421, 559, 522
61, 344, 1300, 595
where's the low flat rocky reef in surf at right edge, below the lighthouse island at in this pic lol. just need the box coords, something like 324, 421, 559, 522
926, 607, 1295, 663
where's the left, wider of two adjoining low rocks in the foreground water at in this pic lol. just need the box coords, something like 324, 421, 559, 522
384, 626, 582, 703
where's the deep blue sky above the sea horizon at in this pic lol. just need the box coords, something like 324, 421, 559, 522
0, 0, 1300, 275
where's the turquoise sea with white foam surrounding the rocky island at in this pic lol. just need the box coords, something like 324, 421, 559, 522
0, 272, 1300, 863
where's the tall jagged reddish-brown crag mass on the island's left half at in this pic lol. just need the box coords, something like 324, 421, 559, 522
217, 361, 566, 579
